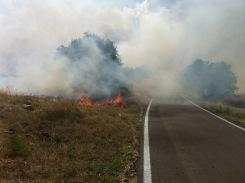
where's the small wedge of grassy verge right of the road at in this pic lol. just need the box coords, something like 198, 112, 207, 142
204, 96, 245, 126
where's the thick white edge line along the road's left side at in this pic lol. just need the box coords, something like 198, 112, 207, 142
143, 100, 152, 183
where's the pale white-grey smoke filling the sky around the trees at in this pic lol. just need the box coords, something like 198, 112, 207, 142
0, 0, 245, 95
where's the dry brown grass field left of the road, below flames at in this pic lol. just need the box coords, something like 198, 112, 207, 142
0, 94, 142, 183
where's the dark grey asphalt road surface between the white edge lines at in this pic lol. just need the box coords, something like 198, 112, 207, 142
140, 99, 245, 183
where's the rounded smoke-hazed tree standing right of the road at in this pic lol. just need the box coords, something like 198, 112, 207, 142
181, 59, 237, 100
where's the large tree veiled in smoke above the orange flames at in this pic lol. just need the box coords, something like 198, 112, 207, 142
57, 33, 132, 99
